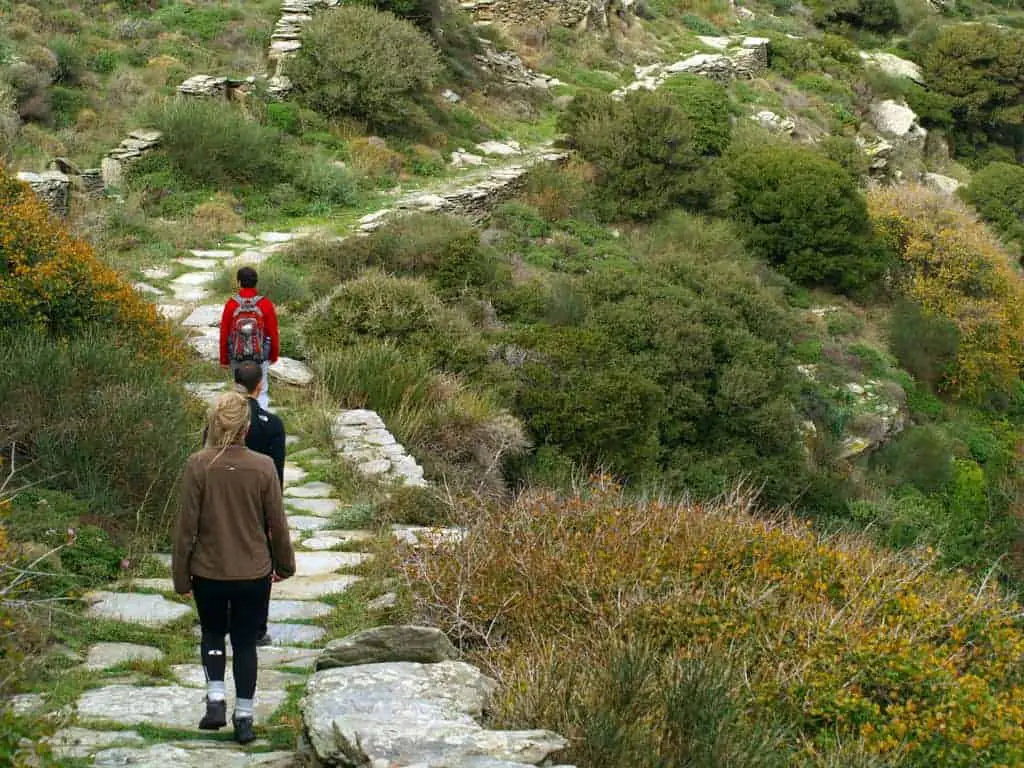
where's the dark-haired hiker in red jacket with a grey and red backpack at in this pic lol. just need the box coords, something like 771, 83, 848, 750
220, 266, 281, 409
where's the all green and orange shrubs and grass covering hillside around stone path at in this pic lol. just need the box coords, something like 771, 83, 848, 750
6, 0, 1024, 768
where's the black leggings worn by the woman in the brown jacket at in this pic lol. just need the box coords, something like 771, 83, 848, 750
193, 574, 270, 698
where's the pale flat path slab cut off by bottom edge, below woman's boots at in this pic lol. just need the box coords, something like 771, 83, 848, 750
93, 744, 295, 768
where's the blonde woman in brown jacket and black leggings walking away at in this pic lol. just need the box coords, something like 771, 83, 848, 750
171, 392, 295, 743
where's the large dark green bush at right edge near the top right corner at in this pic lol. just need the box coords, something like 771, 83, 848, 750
911, 24, 1024, 158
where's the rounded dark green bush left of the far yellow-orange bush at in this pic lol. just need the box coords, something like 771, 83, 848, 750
728, 144, 886, 291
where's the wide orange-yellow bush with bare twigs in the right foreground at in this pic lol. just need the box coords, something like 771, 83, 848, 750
404, 481, 1024, 766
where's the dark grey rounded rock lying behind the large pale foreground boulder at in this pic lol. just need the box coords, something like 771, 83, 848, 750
316, 625, 459, 670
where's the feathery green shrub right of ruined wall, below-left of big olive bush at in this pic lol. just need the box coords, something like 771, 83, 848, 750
146, 98, 284, 187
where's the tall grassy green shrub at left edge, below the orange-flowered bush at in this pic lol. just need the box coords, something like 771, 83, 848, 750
0, 329, 200, 531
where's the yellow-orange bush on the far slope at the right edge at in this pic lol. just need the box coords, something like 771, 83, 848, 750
868, 185, 1024, 399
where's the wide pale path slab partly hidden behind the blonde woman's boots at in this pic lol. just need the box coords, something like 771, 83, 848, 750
77, 685, 287, 731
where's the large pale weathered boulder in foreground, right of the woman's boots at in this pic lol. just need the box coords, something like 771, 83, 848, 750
300, 662, 567, 768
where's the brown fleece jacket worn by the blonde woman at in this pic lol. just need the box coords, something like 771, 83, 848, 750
171, 445, 295, 595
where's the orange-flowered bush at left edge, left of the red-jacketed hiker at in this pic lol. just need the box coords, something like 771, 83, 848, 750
0, 166, 185, 359
